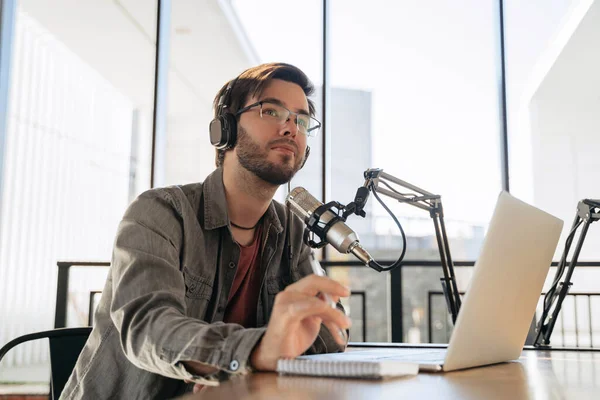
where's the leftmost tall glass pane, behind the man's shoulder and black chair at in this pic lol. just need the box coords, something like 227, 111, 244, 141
0, 0, 157, 382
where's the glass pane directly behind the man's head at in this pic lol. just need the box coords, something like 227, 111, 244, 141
165, 0, 322, 205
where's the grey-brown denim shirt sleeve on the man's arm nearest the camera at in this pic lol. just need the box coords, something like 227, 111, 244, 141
110, 190, 265, 385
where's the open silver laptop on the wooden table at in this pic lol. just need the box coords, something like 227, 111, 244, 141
300, 192, 563, 371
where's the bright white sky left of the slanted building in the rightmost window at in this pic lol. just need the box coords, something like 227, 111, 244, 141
504, 0, 593, 201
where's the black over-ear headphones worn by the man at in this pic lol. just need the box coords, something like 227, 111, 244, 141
208, 76, 310, 169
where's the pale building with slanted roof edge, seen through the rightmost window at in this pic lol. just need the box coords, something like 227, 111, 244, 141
529, 2, 600, 260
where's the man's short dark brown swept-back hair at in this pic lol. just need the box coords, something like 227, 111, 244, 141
213, 63, 315, 167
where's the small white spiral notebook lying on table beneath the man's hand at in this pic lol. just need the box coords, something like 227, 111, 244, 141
277, 355, 419, 379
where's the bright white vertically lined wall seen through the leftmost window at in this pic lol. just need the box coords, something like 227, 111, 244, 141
0, 10, 134, 366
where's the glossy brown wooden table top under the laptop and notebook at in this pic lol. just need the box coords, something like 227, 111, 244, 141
178, 347, 600, 400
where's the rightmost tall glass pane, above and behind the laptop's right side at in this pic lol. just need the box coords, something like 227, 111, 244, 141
504, 0, 600, 260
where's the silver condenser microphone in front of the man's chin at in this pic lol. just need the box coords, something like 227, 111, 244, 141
285, 186, 373, 265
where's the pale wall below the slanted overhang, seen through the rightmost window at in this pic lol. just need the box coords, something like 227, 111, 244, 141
531, 96, 600, 225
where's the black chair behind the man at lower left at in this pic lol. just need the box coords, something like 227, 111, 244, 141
0, 326, 92, 400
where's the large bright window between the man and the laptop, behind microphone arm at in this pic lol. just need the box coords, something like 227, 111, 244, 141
329, 0, 501, 341
